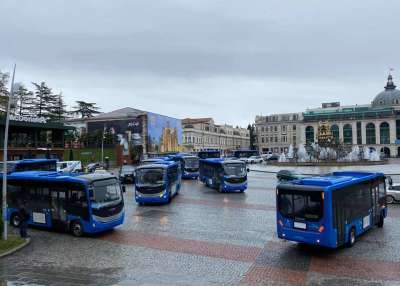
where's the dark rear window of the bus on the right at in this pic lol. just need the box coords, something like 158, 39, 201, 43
278, 190, 323, 221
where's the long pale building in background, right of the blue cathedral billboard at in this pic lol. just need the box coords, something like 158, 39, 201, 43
182, 118, 250, 153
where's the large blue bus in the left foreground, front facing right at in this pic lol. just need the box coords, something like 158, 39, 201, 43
7, 171, 124, 236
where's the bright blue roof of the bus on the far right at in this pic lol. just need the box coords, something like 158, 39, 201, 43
278, 171, 384, 190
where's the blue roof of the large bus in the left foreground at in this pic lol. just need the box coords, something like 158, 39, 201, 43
7, 171, 115, 183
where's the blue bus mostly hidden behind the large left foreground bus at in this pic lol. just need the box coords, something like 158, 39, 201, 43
0, 159, 57, 173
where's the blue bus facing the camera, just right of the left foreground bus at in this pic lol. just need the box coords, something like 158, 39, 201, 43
135, 161, 181, 204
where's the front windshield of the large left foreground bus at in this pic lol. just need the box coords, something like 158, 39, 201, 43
92, 179, 122, 204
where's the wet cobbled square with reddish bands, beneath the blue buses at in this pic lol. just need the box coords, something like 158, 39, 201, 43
0, 169, 400, 286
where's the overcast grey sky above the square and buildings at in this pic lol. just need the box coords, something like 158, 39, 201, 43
0, 0, 400, 126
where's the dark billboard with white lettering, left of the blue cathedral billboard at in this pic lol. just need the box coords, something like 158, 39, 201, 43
87, 117, 143, 155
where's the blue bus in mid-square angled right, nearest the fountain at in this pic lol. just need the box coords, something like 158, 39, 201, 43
199, 158, 249, 192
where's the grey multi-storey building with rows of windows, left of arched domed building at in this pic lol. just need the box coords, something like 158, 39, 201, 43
255, 113, 302, 153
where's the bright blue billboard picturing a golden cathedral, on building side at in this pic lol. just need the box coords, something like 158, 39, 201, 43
147, 112, 182, 153
